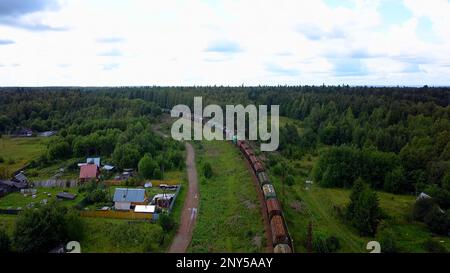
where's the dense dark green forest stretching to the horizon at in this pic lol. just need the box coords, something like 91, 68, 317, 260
0, 86, 450, 242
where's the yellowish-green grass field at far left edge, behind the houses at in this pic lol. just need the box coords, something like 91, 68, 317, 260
0, 136, 49, 178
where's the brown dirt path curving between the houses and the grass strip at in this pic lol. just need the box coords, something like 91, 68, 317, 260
169, 143, 199, 253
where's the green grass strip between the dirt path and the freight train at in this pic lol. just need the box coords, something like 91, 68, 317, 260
188, 141, 265, 253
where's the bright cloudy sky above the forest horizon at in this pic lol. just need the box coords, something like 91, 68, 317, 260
0, 0, 450, 86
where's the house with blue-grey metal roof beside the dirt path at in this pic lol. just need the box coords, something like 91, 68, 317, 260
113, 188, 148, 210
